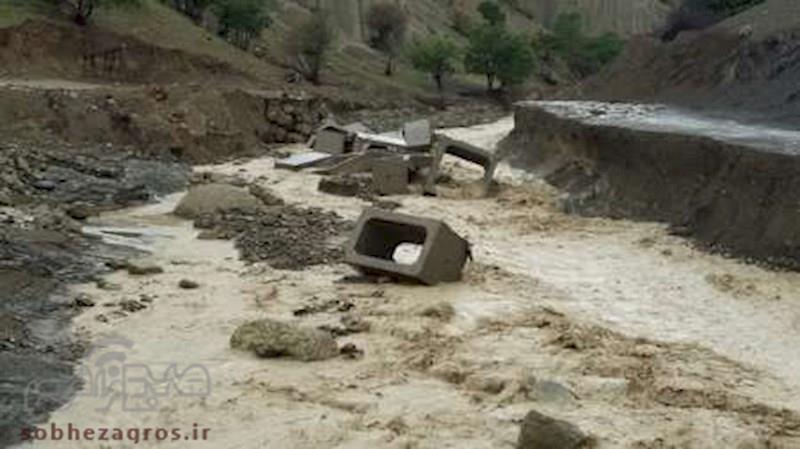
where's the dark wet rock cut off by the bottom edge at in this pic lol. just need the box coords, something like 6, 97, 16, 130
517, 410, 592, 449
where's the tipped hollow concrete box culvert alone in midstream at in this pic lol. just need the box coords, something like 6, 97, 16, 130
344, 208, 469, 285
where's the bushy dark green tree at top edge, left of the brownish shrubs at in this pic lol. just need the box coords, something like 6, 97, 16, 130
213, 0, 271, 49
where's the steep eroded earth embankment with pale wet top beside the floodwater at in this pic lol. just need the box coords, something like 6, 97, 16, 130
505, 102, 800, 268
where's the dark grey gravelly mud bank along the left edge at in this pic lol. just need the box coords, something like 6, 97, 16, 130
0, 146, 187, 446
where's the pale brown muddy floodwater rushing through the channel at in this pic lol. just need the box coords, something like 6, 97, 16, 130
15, 120, 800, 449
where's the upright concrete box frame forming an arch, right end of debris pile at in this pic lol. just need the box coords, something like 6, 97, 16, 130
424, 134, 498, 195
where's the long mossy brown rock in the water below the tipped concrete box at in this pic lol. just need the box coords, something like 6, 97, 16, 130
231, 319, 339, 361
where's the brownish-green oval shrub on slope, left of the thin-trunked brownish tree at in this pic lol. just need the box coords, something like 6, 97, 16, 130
287, 9, 336, 84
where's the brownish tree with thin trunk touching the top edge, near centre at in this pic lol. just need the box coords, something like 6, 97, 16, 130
367, 3, 408, 76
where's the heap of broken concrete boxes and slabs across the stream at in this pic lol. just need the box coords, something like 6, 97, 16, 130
275, 120, 498, 198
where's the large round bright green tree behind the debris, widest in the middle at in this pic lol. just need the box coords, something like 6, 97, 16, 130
464, 24, 536, 92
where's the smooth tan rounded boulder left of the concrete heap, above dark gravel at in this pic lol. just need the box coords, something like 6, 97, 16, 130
174, 184, 263, 218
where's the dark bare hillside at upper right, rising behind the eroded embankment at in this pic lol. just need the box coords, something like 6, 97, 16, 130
583, 0, 800, 124
